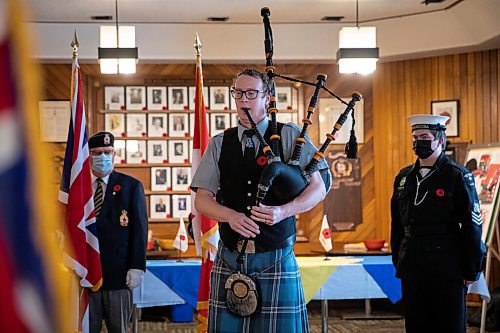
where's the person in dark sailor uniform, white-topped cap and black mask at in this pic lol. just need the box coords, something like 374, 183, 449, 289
391, 115, 485, 333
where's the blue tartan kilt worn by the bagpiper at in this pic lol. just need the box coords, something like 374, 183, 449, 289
208, 242, 309, 333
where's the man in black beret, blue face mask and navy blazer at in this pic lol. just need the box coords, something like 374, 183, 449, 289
88, 132, 148, 333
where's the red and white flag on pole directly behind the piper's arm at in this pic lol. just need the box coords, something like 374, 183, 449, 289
191, 35, 219, 332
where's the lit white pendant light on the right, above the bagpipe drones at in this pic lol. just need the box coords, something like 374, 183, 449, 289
337, 0, 379, 74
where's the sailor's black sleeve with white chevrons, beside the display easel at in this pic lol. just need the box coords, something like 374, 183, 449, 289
454, 173, 486, 281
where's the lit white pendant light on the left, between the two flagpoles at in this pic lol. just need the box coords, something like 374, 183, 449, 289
97, 0, 139, 74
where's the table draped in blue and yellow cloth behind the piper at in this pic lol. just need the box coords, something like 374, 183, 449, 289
134, 255, 489, 332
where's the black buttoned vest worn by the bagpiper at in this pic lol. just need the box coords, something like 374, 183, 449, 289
217, 123, 296, 251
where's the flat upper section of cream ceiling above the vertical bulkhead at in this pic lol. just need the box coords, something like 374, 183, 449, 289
28, 0, 458, 24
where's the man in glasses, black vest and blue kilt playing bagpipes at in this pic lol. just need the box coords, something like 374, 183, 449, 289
191, 69, 331, 332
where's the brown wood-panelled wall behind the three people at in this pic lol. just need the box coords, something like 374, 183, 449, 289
43, 50, 500, 254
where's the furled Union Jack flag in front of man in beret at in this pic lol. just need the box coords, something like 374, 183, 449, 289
59, 45, 102, 332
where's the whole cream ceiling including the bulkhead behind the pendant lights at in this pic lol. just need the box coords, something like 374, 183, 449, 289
25, 0, 500, 63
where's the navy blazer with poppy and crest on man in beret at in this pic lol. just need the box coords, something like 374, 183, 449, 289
97, 171, 148, 290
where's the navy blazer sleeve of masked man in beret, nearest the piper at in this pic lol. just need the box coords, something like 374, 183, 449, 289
128, 181, 148, 271
